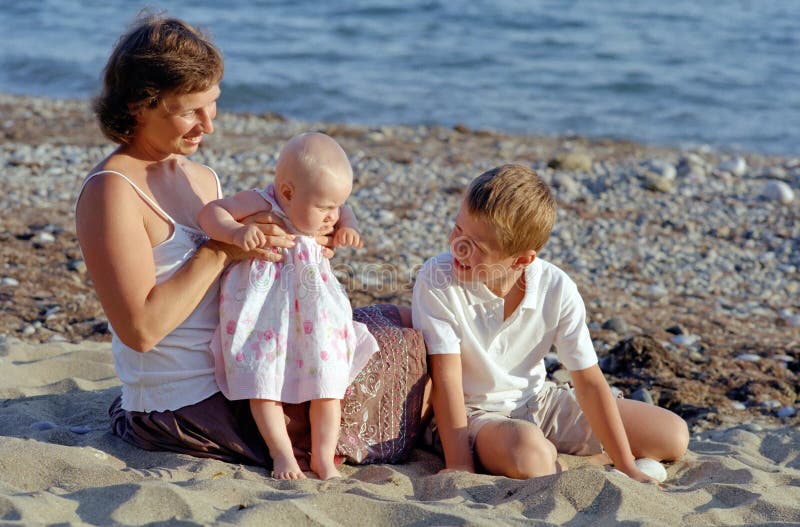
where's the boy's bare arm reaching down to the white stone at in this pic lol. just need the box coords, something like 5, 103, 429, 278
570, 364, 652, 481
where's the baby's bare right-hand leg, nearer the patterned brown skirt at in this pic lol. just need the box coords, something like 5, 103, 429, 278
309, 399, 342, 479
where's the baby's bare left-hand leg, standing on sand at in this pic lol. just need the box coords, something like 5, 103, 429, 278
250, 399, 306, 479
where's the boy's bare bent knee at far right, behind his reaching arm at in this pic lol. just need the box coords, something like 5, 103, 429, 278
617, 399, 689, 461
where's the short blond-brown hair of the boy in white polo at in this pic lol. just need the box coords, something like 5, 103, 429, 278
464, 164, 556, 256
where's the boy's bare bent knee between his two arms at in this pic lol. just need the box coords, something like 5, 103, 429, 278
475, 419, 559, 479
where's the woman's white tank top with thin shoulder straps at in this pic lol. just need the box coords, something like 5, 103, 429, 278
78, 168, 222, 412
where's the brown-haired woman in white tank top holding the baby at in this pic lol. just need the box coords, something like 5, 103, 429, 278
76, 16, 428, 465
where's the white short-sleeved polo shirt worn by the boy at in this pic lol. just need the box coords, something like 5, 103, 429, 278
411, 252, 597, 414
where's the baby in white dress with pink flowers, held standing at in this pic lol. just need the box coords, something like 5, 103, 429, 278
198, 133, 378, 479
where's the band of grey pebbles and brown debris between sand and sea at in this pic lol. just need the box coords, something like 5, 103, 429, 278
0, 95, 800, 431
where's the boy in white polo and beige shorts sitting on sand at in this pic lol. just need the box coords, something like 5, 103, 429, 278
412, 165, 689, 481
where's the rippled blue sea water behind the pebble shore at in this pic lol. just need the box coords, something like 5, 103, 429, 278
0, 0, 800, 155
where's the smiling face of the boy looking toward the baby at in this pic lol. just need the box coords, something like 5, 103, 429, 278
449, 203, 518, 296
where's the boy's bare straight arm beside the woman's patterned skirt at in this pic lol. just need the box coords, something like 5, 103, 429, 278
428, 354, 475, 472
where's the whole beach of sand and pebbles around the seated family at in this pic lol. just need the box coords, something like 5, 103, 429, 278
0, 95, 800, 526
